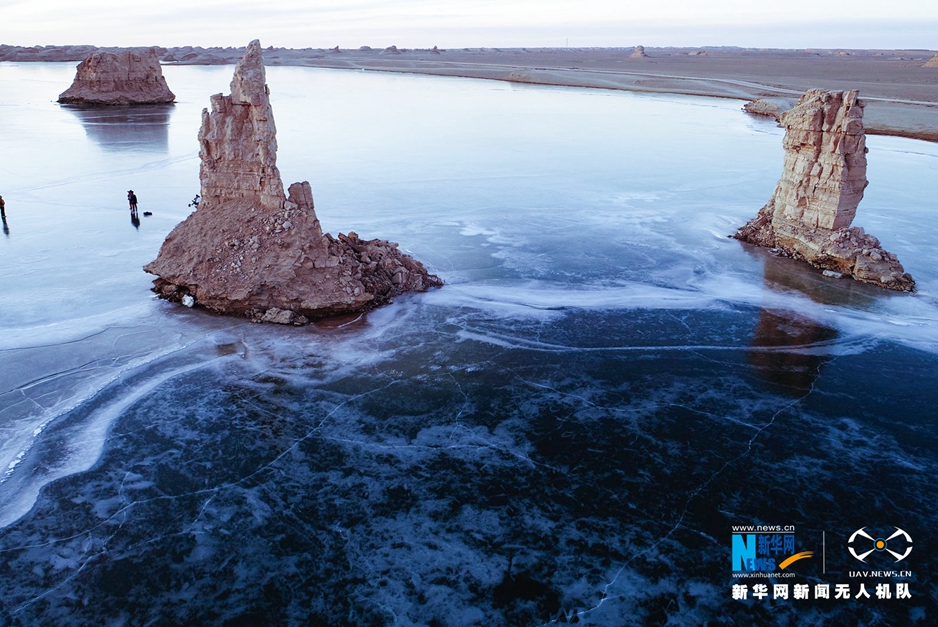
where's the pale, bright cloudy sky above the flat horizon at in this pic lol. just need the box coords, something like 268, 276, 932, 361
0, 0, 938, 50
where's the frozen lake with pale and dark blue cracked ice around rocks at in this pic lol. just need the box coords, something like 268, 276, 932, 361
0, 63, 938, 626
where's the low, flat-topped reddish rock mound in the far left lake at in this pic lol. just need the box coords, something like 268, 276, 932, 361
59, 48, 176, 105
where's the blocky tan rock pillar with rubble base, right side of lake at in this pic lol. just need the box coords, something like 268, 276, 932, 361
733, 89, 915, 292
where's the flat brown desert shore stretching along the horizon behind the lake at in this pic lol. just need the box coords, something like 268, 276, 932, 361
7, 46, 938, 142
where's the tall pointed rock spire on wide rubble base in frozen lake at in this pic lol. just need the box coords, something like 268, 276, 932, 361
144, 40, 442, 324
